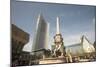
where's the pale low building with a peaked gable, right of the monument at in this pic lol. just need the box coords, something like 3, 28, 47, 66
66, 35, 95, 55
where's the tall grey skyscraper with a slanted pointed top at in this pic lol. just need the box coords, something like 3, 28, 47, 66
32, 14, 49, 51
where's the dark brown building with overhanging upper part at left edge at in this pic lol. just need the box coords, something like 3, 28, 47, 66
11, 24, 29, 65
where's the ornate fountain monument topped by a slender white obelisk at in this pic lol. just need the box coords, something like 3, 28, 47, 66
53, 17, 65, 56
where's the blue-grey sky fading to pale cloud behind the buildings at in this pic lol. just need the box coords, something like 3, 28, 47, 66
11, 0, 96, 51
